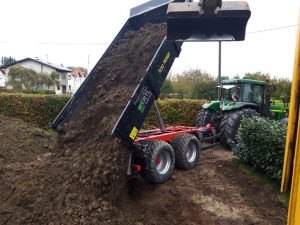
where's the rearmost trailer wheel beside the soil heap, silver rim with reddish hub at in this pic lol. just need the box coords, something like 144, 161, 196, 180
141, 141, 175, 184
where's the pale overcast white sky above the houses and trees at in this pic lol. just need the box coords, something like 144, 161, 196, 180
0, 0, 300, 79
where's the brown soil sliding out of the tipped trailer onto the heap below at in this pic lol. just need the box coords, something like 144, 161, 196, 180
0, 24, 165, 224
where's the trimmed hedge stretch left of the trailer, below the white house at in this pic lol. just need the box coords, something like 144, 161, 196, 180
0, 93, 70, 127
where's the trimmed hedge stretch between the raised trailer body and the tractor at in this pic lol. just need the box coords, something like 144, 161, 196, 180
144, 99, 206, 127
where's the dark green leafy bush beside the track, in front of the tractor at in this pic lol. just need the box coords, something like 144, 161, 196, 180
233, 117, 286, 179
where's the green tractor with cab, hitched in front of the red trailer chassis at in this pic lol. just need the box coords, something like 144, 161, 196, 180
196, 79, 287, 145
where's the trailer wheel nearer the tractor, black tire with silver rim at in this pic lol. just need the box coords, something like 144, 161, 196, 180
171, 134, 201, 170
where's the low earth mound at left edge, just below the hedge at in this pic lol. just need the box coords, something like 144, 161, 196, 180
0, 115, 56, 165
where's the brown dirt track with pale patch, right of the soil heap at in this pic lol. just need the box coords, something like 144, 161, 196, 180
113, 146, 287, 225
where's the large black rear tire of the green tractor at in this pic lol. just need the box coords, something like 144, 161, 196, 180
220, 108, 259, 147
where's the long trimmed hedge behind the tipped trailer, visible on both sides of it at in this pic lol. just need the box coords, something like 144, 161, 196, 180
0, 93, 205, 127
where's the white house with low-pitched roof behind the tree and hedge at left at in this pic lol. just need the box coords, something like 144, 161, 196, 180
2, 58, 72, 94
